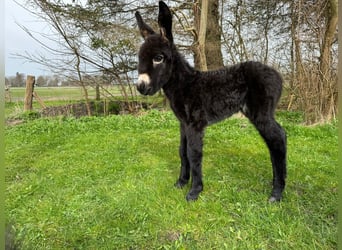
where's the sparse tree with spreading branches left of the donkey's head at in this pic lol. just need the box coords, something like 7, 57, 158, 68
19, 0, 143, 115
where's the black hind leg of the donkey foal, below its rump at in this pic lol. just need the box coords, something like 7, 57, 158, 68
251, 114, 286, 202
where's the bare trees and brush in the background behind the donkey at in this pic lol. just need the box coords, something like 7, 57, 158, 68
7, 0, 338, 123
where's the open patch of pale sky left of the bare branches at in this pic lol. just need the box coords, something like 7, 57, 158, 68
5, 0, 51, 77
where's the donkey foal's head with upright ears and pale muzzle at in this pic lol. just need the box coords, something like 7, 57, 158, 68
135, 1, 173, 95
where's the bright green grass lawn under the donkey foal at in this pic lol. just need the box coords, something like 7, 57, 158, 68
5, 111, 338, 250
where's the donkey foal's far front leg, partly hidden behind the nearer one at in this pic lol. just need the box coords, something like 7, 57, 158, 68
175, 123, 190, 188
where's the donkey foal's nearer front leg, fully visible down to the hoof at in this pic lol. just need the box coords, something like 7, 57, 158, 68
186, 127, 204, 201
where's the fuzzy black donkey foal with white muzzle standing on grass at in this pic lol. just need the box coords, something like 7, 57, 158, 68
135, 1, 286, 202
